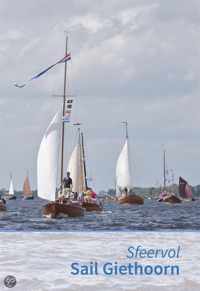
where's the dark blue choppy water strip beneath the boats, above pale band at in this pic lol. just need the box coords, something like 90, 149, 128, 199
0, 198, 200, 231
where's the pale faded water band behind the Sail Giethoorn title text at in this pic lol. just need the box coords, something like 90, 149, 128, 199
0, 232, 200, 291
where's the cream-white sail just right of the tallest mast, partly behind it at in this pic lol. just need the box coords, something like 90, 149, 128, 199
67, 137, 86, 193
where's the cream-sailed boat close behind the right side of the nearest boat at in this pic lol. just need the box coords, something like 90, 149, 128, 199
67, 128, 103, 211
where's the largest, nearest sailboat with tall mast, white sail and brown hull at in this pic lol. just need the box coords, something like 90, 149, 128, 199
37, 38, 84, 218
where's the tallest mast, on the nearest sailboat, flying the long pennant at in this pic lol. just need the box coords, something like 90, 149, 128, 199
60, 36, 68, 185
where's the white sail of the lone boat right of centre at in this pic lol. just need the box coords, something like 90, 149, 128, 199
116, 139, 132, 195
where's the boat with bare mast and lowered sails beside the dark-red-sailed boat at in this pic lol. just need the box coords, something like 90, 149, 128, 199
158, 150, 181, 204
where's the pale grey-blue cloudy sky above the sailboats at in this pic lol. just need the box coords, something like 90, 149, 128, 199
0, 0, 200, 190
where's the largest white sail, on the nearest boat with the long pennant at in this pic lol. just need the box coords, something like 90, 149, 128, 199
37, 112, 62, 201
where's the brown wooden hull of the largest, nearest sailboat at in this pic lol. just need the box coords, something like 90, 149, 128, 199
43, 202, 84, 218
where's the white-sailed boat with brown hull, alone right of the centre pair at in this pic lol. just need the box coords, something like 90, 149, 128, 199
116, 121, 144, 204
